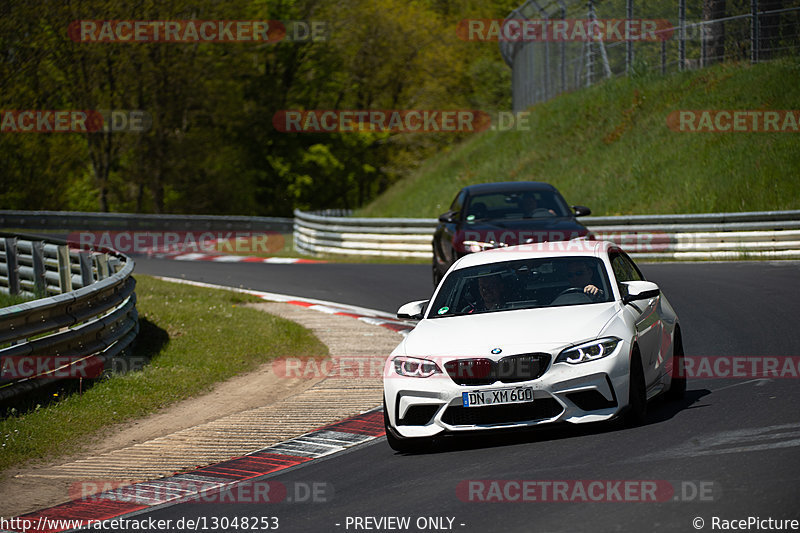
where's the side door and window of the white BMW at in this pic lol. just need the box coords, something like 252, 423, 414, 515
609, 250, 664, 386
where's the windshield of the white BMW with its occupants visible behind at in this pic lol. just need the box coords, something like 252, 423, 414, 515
428, 257, 613, 318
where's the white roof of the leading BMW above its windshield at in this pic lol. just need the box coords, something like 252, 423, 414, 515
454, 238, 617, 270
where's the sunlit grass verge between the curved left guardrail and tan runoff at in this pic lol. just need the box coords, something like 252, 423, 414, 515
0, 276, 328, 473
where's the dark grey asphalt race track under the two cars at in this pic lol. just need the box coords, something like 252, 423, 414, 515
122, 258, 800, 533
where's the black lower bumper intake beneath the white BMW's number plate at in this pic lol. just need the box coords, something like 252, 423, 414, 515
442, 398, 564, 426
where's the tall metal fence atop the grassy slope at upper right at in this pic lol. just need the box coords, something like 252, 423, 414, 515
500, 0, 800, 111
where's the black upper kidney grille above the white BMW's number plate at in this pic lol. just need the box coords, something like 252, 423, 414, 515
444, 353, 550, 386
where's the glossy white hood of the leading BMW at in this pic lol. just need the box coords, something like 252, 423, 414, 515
405, 302, 619, 356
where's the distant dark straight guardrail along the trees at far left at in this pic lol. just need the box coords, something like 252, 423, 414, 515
0, 211, 292, 233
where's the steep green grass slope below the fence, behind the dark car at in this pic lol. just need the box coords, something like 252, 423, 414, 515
357, 58, 800, 217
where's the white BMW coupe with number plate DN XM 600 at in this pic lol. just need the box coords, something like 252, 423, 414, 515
384, 239, 686, 451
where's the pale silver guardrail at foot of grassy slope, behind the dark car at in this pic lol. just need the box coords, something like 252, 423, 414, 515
294, 211, 800, 260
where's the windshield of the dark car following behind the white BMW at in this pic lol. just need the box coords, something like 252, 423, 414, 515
466, 191, 572, 222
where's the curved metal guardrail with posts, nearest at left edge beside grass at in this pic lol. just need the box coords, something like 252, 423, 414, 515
0, 233, 139, 400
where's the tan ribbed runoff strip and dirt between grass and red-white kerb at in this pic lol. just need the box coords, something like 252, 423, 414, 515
0, 303, 401, 517
